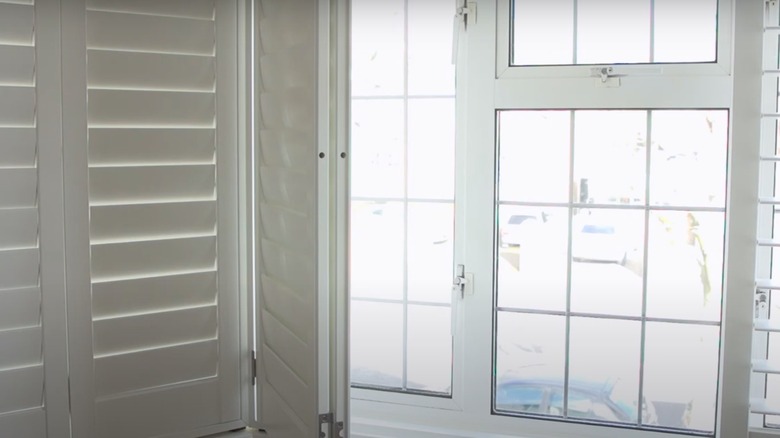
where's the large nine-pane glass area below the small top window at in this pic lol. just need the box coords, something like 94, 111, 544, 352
494, 110, 729, 432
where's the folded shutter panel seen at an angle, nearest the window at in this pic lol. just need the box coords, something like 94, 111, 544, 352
255, 0, 332, 438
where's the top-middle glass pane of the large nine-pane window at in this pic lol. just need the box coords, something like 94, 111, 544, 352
574, 111, 647, 204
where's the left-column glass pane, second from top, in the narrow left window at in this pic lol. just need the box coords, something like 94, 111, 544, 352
350, 100, 405, 198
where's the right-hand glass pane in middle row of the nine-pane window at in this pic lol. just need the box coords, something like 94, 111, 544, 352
647, 210, 726, 321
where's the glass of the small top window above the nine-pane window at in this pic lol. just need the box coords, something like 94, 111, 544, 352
511, 0, 718, 66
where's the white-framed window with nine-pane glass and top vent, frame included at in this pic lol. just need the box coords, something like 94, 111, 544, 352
352, 0, 764, 437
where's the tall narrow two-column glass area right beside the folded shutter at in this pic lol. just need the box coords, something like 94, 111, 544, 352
350, 0, 455, 396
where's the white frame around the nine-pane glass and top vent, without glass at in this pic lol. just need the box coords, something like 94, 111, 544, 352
351, 0, 764, 438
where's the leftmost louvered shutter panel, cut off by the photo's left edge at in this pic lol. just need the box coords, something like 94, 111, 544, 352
0, 1, 46, 438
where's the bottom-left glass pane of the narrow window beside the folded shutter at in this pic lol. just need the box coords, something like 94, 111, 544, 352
349, 300, 404, 388
